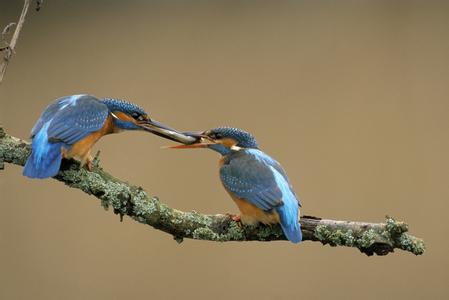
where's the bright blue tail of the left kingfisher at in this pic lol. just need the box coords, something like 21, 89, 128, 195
23, 122, 62, 178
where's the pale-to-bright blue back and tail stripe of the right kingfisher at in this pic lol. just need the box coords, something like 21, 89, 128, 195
270, 167, 302, 243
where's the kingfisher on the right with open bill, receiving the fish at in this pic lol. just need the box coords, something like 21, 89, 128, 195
169, 127, 302, 243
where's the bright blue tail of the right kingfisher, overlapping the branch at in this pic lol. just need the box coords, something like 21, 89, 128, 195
276, 199, 302, 244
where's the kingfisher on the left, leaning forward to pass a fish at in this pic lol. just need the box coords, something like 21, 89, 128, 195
23, 94, 195, 178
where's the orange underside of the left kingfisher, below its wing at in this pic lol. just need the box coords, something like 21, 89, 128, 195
62, 116, 116, 165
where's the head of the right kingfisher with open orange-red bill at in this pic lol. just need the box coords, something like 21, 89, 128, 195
170, 127, 259, 155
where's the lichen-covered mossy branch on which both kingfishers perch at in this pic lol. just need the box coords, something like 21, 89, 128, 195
0, 125, 425, 255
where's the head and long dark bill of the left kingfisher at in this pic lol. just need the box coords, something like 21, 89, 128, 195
102, 99, 196, 144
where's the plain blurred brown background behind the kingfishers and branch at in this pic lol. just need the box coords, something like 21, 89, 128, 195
0, 0, 449, 299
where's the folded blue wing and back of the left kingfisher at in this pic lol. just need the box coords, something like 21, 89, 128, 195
45, 95, 109, 145
